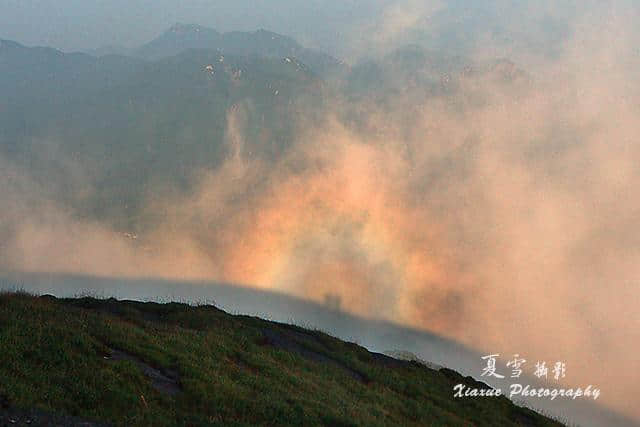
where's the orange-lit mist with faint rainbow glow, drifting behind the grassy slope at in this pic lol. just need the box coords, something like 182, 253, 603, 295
0, 1, 640, 426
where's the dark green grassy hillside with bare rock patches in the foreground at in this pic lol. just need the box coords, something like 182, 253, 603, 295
0, 294, 556, 426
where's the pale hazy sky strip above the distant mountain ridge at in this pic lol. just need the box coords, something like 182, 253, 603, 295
0, 0, 584, 62
